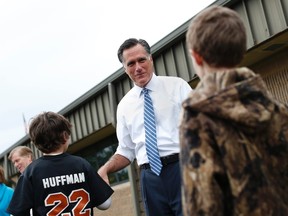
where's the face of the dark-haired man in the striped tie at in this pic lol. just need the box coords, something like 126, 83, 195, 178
123, 44, 153, 87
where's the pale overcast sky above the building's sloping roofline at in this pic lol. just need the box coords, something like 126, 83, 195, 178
0, 0, 214, 153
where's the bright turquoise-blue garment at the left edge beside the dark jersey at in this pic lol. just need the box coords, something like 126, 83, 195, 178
0, 183, 14, 216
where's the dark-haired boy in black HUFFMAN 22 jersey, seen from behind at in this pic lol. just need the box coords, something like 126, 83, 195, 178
8, 112, 113, 216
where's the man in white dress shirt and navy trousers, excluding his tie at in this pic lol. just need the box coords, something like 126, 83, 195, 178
98, 38, 192, 216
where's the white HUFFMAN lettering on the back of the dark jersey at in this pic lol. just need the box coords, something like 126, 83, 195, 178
42, 172, 85, 188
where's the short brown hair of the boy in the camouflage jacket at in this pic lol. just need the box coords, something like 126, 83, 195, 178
186, 6, 247, 67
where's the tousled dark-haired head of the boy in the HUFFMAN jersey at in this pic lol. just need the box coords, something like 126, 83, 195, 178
29, 112, 72, 154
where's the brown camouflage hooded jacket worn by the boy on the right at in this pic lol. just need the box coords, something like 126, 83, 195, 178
180, 68, 288, 216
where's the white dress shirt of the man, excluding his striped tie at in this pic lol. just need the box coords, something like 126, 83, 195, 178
116, 74, 192, 165
